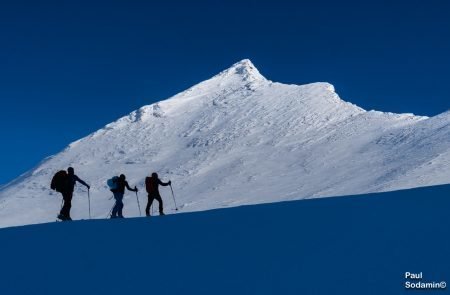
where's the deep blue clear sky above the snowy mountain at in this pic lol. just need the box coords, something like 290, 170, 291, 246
0, 0, 450, 184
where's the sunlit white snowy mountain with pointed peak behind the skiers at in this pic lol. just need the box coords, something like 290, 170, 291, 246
0, 60, 450, 227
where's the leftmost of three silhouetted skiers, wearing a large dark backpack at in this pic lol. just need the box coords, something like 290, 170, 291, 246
50, 167, 91, 221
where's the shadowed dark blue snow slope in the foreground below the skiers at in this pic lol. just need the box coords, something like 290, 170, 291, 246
0, 185, 450, 295
